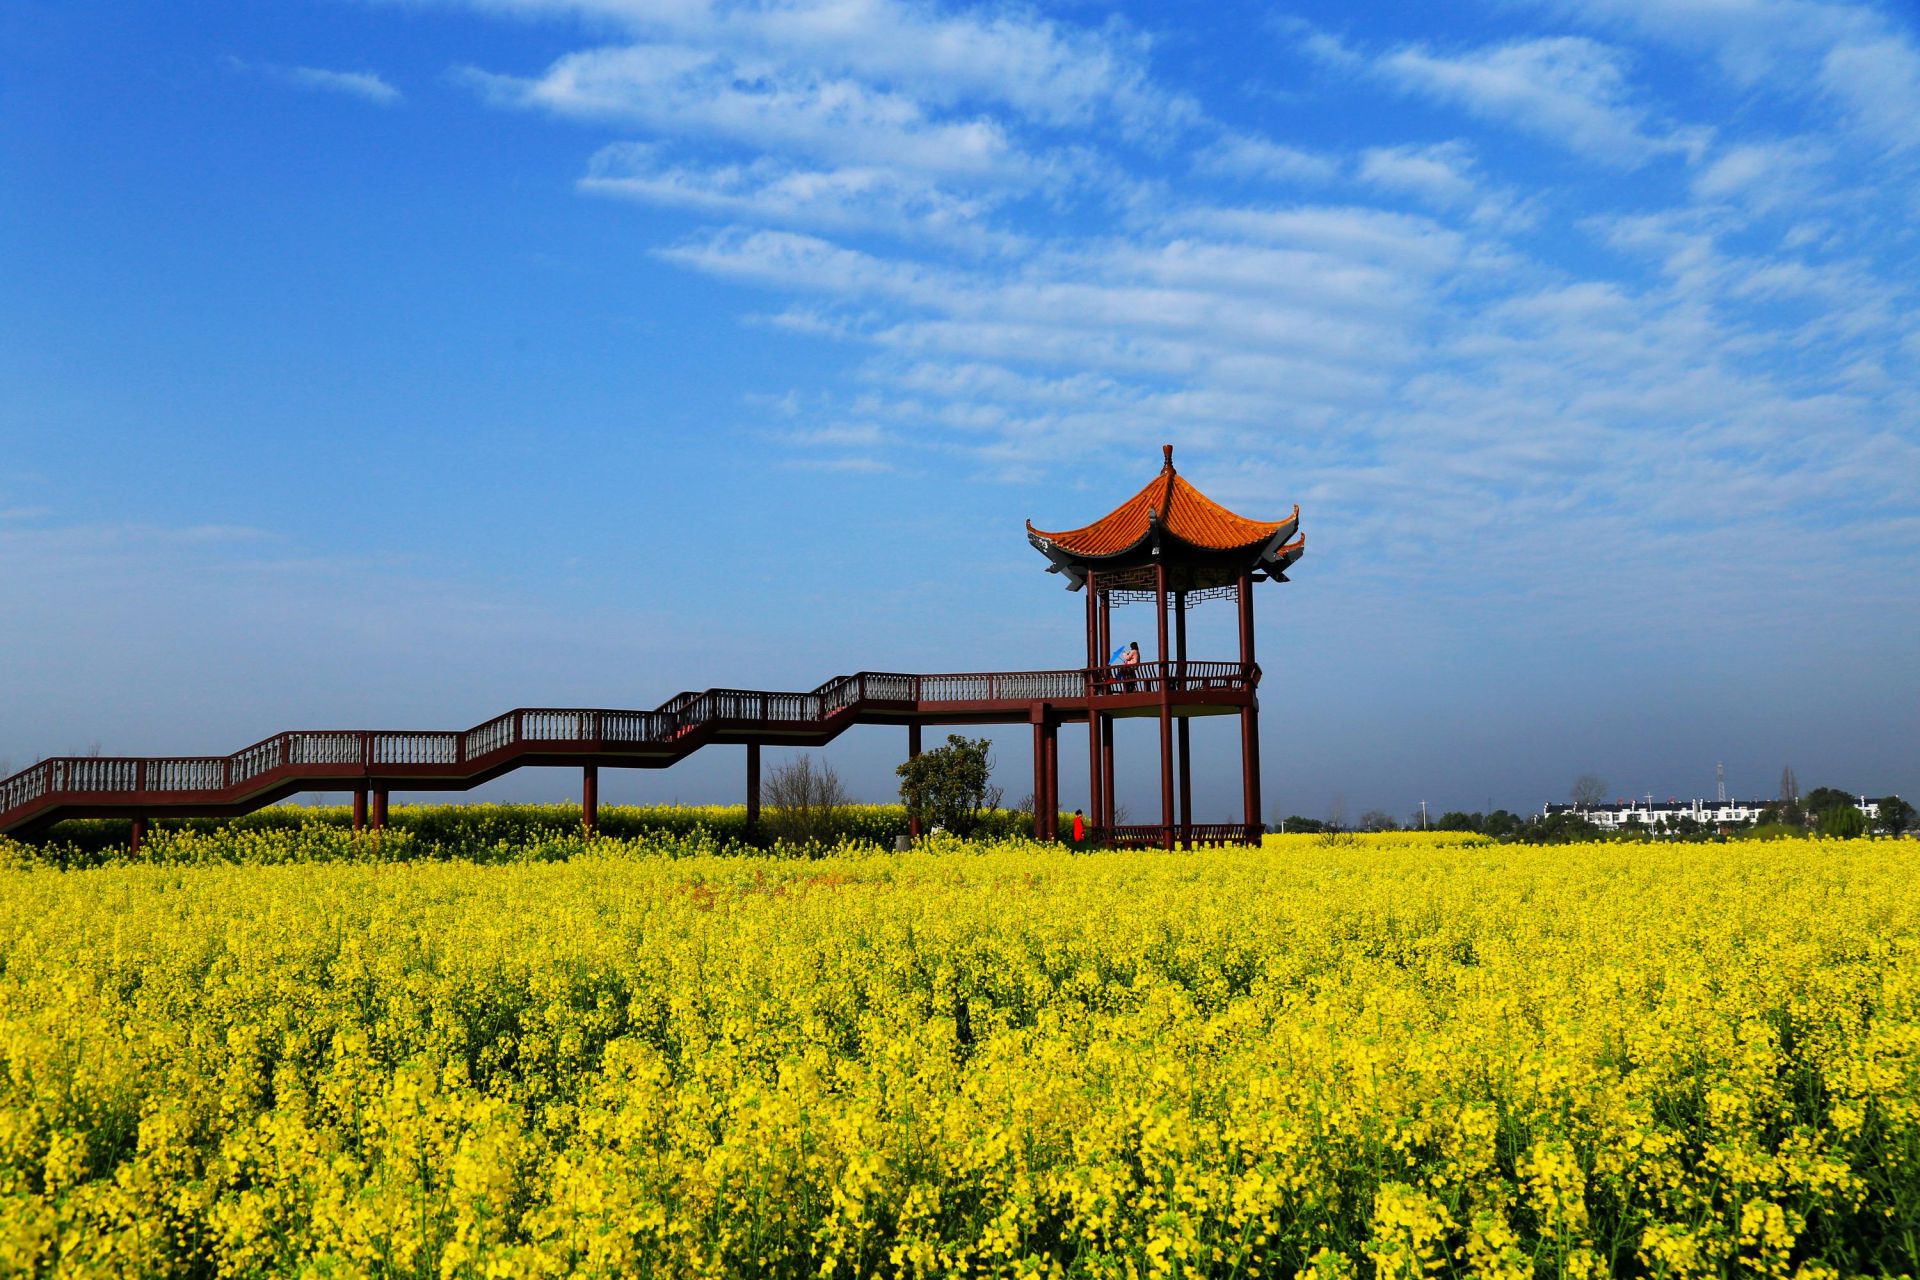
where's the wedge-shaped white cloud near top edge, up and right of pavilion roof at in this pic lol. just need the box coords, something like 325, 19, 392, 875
1373, 36, 1701, 167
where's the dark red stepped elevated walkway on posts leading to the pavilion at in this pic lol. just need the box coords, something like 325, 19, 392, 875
0, 660, 1260, 842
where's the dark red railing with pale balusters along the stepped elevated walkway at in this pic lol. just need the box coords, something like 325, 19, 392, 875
0, 662, 1260, 841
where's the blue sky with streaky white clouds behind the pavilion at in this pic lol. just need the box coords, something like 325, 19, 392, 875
0, 0, 1920, 818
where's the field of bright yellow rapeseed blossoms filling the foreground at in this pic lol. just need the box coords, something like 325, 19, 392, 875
0, 833, 1920, 1278
